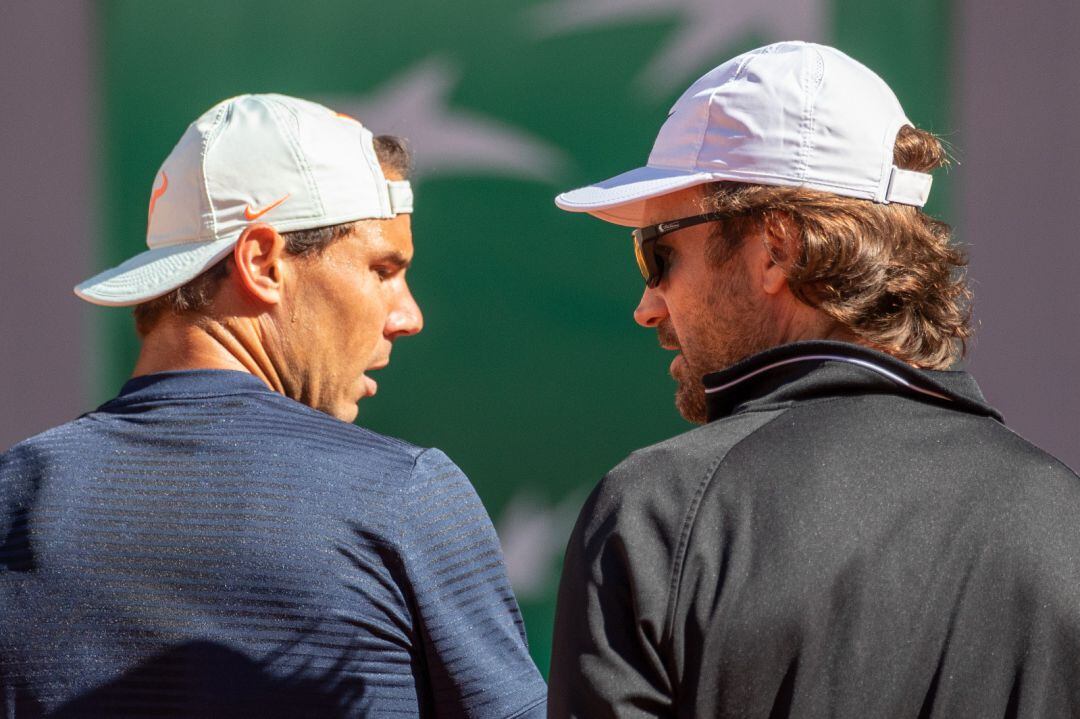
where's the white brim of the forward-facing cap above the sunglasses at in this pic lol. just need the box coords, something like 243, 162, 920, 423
555, 166, 714, 227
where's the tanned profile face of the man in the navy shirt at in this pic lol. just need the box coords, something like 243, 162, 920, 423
281, 206, 423, 422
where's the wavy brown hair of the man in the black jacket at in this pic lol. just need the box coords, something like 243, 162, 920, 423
705, 126, 972, 369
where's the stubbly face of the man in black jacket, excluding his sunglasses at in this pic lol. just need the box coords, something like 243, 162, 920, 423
634, 188, 775, 423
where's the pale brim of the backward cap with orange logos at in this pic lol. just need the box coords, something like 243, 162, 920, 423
75, 236, 237, 307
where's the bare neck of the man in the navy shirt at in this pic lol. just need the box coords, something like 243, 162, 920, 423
132, 316, 284, 394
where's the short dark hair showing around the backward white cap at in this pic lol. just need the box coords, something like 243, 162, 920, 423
133, 135, 413, 337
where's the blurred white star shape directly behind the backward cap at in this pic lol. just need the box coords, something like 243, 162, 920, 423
320, 59, 567, 182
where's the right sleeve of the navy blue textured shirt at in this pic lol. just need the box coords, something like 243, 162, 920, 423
399, 449, 546, 719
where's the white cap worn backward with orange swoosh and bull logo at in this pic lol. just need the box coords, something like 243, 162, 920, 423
75, 95, 413, 306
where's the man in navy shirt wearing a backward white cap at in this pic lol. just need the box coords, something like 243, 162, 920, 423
0, 95, 545, 718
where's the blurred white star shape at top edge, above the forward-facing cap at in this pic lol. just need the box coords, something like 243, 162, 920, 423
529, 0, 828, 96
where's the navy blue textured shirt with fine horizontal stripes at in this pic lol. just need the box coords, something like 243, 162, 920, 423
0, 370, 545, 719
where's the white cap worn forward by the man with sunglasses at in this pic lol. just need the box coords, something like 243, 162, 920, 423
555, 42, 932, 227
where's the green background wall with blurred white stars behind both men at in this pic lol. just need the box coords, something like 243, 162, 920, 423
94, 0, 954, 671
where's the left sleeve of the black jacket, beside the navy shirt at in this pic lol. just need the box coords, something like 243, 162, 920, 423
548, 469, 673, 719
